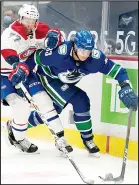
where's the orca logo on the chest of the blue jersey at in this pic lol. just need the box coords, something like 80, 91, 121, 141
58, 69, 85, 83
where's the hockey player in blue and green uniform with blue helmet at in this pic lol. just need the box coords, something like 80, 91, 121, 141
8, 30, 138, 154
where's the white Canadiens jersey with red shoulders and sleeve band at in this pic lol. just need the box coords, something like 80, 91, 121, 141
1, 21, 50, 76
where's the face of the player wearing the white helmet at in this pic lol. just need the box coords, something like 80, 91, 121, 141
21, 17, 36, 34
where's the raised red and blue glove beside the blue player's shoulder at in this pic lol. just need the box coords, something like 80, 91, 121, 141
44, 28, 63, 50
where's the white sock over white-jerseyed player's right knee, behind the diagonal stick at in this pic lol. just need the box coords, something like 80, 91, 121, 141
32, 91, 54, 114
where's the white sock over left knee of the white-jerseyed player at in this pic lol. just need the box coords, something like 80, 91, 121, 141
6, 93, 30, 125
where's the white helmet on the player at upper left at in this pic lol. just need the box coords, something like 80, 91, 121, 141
18, 4, 39, 20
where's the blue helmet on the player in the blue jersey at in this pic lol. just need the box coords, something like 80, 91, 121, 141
74, 30, 94, 51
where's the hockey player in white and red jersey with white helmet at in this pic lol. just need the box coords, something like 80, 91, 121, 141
1, 4, 72, 153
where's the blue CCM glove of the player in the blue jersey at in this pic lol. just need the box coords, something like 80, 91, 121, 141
118, 84, 138, 111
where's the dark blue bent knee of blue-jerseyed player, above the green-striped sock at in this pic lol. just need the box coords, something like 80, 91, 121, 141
69, 90, 90, 113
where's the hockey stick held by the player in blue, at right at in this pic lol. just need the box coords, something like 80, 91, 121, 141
99, 108, 133, 184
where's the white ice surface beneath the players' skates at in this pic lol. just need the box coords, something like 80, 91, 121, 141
1, 132, 138, 184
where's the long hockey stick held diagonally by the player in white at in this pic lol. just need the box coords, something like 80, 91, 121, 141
17, 82, 95, 184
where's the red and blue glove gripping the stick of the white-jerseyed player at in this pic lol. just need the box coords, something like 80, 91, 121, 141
8, 62, 29, 86
